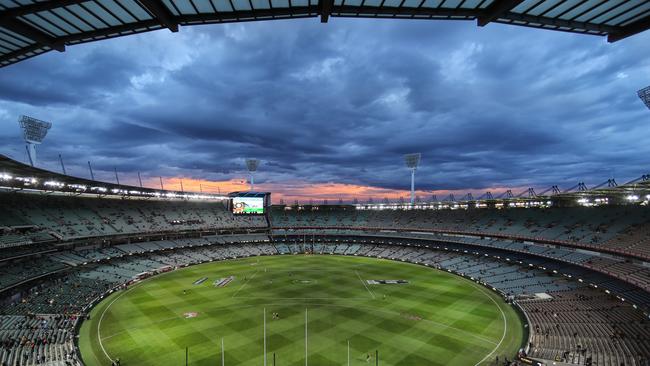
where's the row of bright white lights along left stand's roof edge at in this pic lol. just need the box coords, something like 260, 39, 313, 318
0, 172, 227, 200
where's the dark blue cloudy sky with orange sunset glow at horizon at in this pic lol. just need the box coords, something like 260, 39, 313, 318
0, 19, 650, 200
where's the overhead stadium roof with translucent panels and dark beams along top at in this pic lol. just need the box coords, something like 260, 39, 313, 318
0, 0, 650, 67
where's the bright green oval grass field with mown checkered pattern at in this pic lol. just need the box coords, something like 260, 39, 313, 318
79, 255, 523, 366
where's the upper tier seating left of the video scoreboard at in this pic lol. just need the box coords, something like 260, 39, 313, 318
0, 193, 267, 243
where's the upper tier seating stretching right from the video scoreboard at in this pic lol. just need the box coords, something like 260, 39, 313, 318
272, 206, 650, 259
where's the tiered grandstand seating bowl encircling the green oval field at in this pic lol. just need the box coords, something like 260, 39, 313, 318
0, 158, 650, 366
